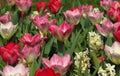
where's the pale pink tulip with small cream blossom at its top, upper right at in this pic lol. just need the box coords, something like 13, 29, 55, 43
87, 9, 104, 25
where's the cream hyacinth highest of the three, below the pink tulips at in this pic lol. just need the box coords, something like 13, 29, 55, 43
89, 32, 103, 50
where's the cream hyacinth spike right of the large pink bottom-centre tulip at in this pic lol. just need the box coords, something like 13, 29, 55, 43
74, 50, 90, 76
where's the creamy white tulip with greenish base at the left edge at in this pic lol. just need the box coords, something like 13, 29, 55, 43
0, 22, 17, 40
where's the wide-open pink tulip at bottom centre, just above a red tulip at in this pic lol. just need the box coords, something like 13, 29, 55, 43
42, 54, 72, 75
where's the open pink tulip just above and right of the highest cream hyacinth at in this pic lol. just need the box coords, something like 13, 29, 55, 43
96, 19, 114, 37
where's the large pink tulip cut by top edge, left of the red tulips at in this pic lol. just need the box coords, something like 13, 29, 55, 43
15, 0, 33, 12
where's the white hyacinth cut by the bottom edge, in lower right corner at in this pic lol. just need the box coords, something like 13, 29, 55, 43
98, 63, 116, 76
